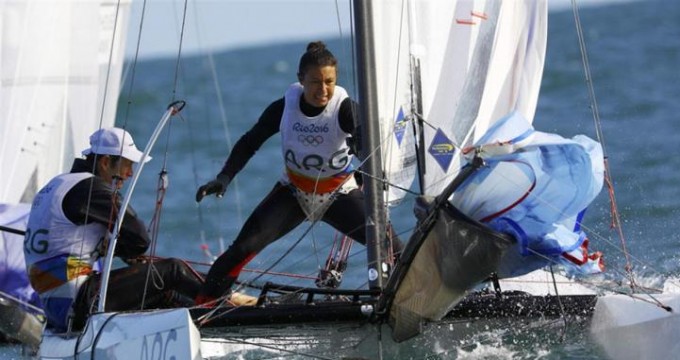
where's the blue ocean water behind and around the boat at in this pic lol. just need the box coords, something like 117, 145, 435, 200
0, 1, 680, 359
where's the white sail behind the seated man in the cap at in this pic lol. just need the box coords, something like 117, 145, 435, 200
0, 0, 129, 203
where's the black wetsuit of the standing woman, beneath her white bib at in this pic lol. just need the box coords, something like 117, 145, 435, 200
199, 97, 401, 302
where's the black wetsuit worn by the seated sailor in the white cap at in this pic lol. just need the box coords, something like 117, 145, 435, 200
62, 159, 202, 329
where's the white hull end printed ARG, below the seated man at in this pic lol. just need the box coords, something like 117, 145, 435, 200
38, 309, 202, 359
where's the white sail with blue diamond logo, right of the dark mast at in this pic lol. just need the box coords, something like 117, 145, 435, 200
375, 0, 547, 195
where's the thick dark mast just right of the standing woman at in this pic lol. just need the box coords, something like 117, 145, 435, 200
354, 1, 390, 289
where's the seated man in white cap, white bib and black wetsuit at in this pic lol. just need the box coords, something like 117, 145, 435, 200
24, 127, 202, 331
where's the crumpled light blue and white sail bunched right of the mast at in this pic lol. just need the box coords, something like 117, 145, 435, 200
451, 112, 604, 278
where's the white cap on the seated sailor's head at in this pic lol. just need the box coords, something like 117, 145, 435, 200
82, 127, 151, 163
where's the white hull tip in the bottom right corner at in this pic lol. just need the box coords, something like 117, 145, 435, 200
591, 294, 680, 360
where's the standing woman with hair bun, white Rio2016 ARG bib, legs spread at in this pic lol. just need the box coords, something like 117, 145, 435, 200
196, 41, 401, 303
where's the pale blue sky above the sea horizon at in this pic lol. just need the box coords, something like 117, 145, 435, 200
126, 0, 636, 59
